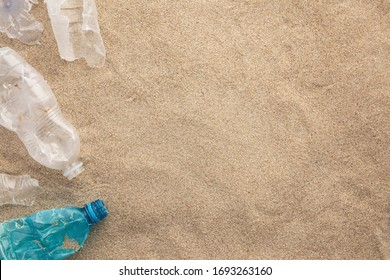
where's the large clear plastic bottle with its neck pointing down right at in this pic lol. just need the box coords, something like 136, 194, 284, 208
0, 48, 83, 180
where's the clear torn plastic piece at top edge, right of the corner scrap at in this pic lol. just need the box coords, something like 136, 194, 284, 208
45, 0, 106, 67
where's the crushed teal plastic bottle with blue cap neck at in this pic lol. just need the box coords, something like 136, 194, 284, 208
0, 199, 108, 260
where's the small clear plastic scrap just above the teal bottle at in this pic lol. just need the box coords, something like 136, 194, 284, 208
0, 174, 43, 206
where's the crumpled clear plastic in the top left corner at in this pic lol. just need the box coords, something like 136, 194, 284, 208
0, 0, 43, 45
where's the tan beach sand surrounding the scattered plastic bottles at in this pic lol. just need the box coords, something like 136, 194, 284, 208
0, 0, 390, 259
